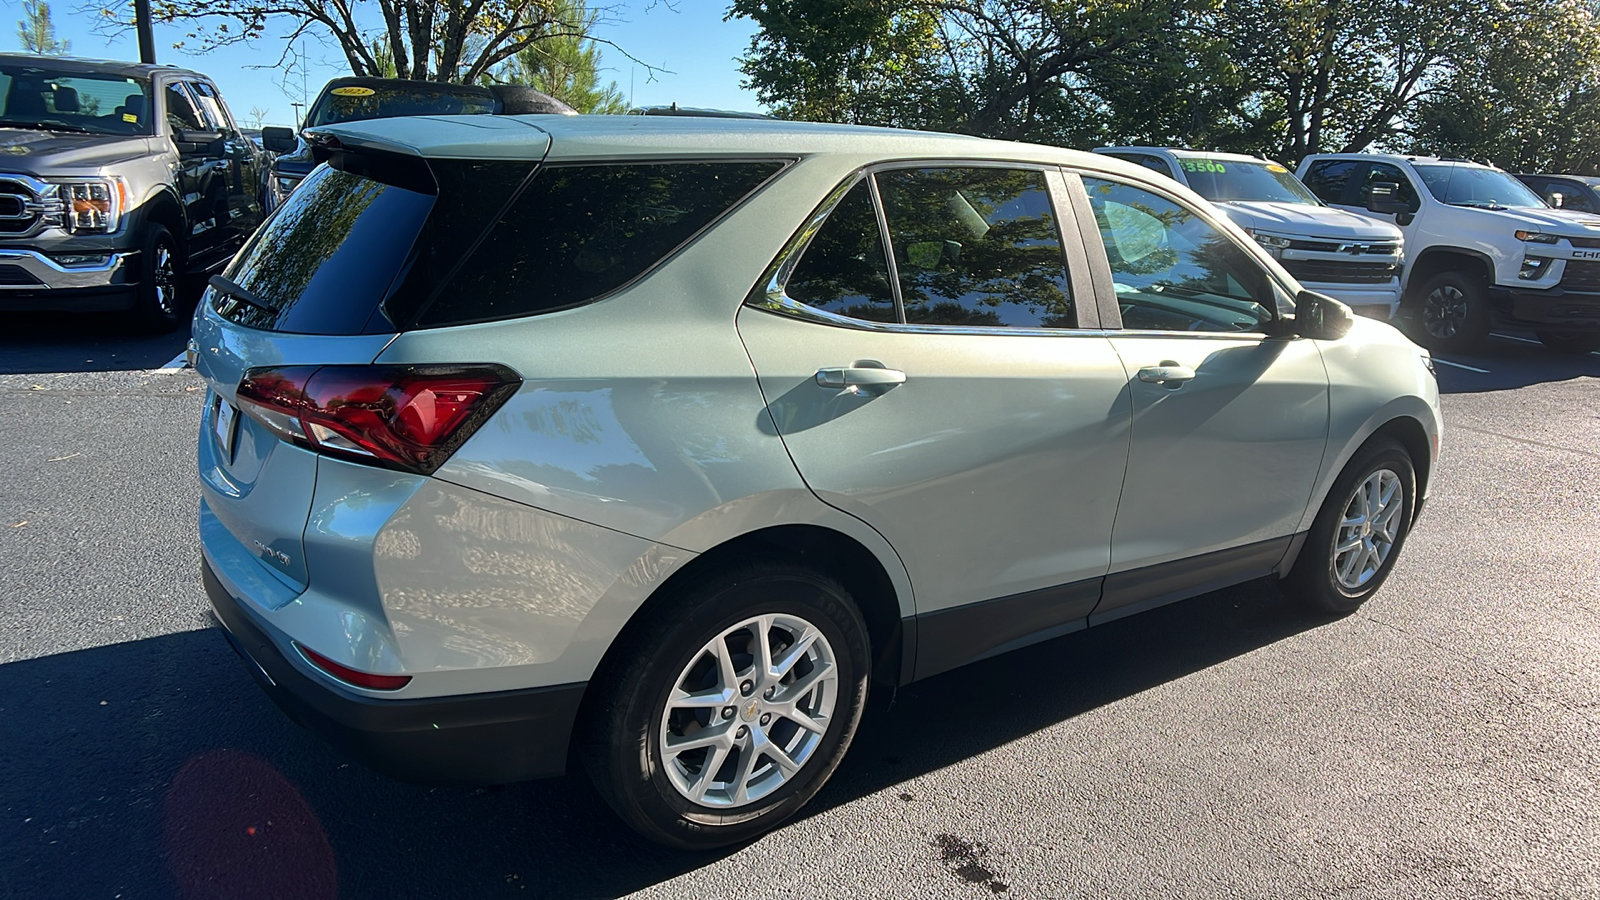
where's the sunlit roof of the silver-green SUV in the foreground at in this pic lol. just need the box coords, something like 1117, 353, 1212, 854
310, 115, 1126, 168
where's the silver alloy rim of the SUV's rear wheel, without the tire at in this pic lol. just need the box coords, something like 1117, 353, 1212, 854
658, 613, 838, 809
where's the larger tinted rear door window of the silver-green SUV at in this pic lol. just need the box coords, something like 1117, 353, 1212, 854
875, 167, 1077, 328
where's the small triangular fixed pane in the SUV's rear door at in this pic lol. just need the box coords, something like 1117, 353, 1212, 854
784, 181, 898, 322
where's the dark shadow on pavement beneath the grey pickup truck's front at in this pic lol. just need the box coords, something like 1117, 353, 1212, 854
0, 312, 189, 375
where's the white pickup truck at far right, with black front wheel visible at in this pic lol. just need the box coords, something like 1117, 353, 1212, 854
1299, 154, 1600, 352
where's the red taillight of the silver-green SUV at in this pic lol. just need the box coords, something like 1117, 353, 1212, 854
237, 365, 522, 476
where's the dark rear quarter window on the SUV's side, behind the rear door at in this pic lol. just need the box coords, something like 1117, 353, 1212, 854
416, 160, 784, 327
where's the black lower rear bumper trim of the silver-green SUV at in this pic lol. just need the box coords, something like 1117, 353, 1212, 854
202, 560, 586, 785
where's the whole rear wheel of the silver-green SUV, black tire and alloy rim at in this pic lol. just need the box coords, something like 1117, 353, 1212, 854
579, 562, 870, 850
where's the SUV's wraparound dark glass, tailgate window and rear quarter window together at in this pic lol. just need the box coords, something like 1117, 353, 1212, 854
211, 154, 786, 335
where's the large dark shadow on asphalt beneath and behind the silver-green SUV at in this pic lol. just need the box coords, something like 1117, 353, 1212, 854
0, 581, 1326, 900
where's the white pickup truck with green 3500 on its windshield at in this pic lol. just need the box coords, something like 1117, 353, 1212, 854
1094, 147, 1403, 319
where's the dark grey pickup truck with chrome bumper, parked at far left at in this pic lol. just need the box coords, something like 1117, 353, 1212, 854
0, 53, 267, 330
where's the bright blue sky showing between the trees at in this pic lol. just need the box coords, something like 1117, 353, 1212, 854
12, 0, 760, 125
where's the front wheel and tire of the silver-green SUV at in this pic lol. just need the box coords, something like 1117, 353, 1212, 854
1283, 437, 1416, 615
